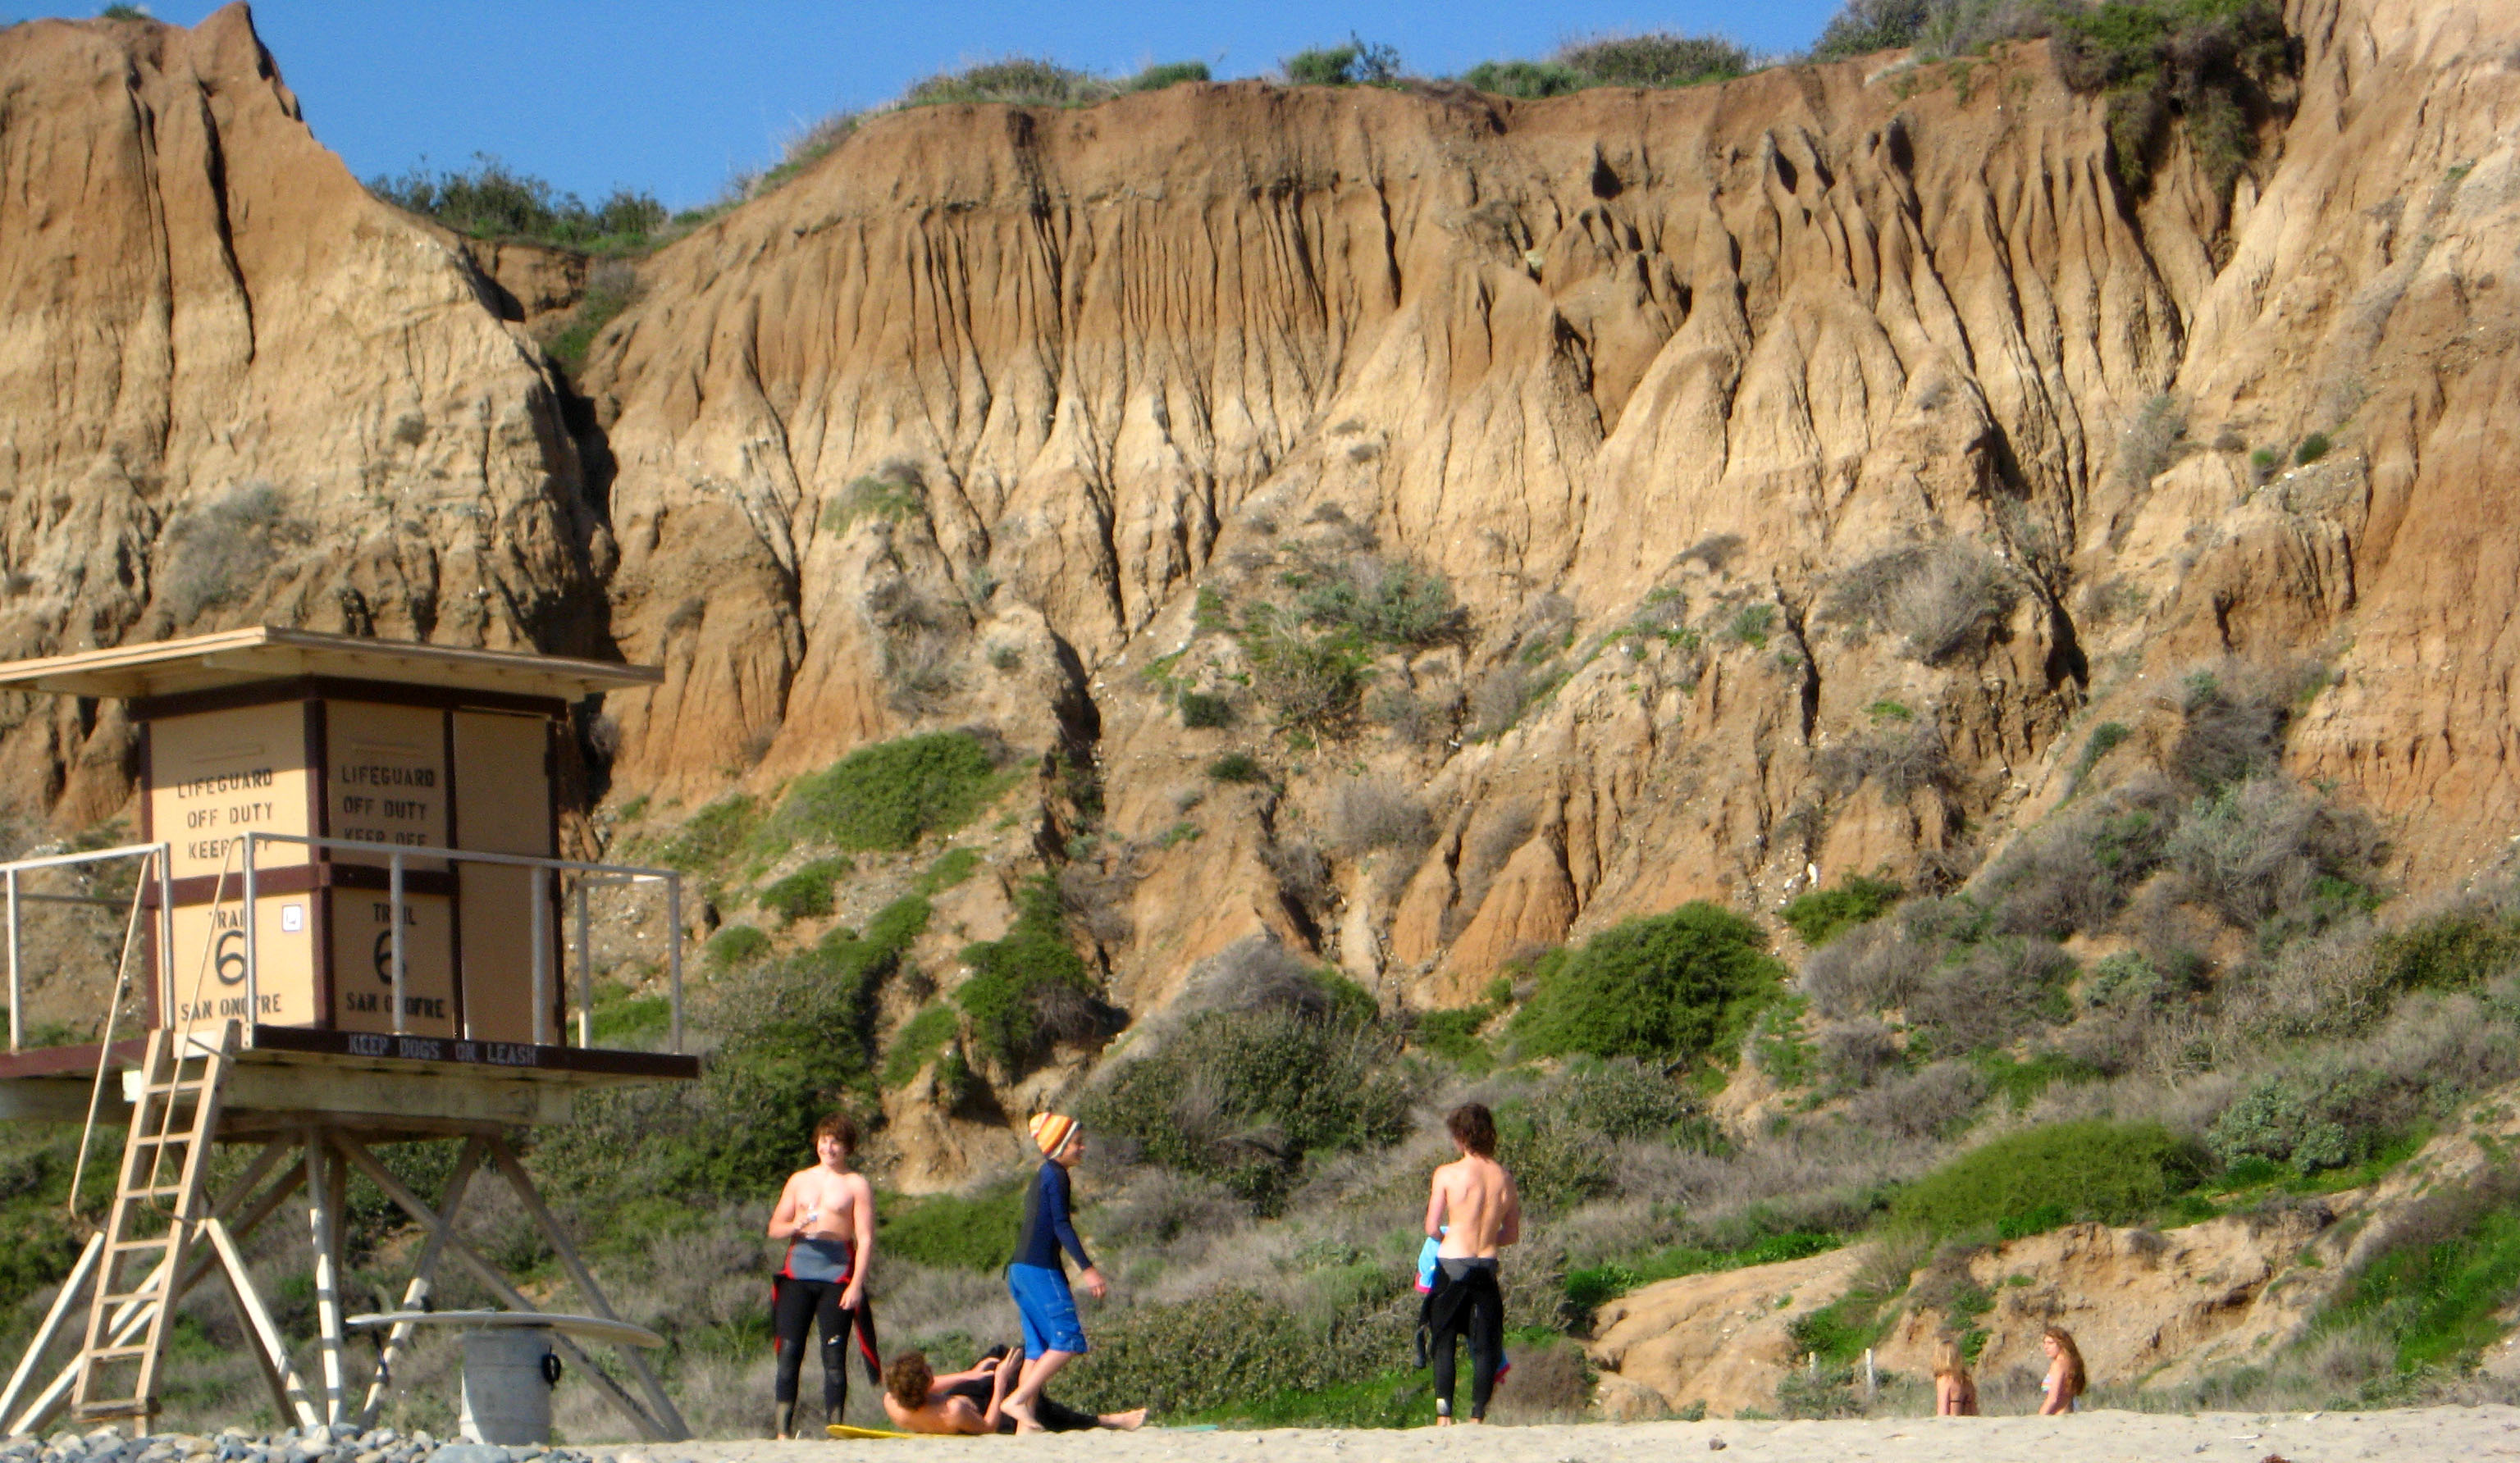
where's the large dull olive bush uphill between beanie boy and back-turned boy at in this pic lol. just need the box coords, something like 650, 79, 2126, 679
1084, 1002, 1411, 1211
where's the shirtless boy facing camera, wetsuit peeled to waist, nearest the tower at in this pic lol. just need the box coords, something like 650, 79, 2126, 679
766, 1113, 874, 1438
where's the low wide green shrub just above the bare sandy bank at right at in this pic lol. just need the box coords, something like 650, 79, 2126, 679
1890, 1118, 2205, 1237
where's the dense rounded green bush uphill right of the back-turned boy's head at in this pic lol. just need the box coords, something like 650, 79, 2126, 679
1512, 901, 1784, 1063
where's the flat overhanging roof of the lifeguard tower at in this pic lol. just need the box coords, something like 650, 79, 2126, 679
0, 625, 665, 700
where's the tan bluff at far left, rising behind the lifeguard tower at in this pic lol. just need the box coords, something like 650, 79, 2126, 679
0, 5, 605, 823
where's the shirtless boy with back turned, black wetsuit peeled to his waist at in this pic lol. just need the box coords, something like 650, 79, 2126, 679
1427, 1103, 1522, 1428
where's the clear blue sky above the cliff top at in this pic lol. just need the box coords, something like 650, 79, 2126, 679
54, 0, 1837, 209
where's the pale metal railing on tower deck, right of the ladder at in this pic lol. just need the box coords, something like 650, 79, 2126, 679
240, 828, 683, 1052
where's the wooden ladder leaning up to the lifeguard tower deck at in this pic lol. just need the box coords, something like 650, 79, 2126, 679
71, 1023, 237, 1423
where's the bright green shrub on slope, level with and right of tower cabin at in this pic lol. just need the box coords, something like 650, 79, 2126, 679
769, 733, 1001, 849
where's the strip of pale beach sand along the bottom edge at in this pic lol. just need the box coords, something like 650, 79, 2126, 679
618, 1405, 2520, 1463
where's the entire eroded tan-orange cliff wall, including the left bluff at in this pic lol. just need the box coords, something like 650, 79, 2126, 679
0, 0, 2520, 1007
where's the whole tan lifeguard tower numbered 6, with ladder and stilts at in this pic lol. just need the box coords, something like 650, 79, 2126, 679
0, 627, 698, 1440
